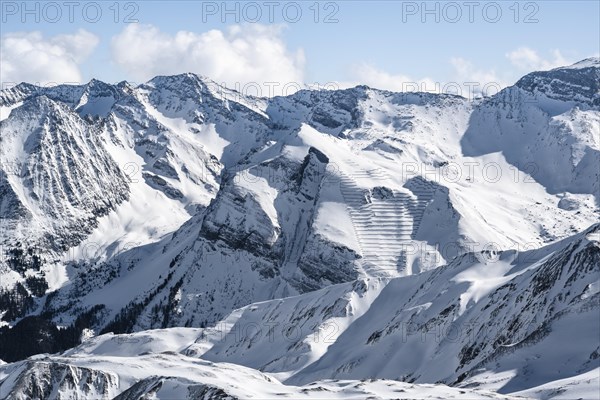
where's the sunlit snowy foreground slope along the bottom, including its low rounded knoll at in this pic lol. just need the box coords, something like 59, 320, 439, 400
0, 328, 514, 400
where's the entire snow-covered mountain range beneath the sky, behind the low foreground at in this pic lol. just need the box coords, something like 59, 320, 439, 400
0, 59, 600, 398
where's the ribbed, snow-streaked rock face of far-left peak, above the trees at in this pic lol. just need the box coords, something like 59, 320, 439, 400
2, 96, 129, 251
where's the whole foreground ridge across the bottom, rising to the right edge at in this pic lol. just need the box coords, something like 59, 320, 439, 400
0, 224, 600, 399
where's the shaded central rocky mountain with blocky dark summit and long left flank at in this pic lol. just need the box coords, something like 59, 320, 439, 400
45, 144, 358, 332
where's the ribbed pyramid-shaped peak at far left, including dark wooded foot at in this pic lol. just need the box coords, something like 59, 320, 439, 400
0, 95, 130, 308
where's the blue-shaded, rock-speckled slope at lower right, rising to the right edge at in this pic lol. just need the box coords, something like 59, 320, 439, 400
290, 225, 600, 393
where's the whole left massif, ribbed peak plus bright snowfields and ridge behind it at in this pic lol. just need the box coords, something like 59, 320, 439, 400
0, 76, 265, 321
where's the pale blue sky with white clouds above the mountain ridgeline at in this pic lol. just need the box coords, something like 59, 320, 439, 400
0, 1, 600, 95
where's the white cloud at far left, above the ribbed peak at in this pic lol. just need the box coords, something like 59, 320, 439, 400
0, 29, 99, 85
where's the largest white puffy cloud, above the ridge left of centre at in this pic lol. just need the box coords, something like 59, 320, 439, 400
112, 24, 305, 95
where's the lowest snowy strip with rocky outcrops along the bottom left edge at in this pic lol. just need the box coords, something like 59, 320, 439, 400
0, 346, 516, 400
